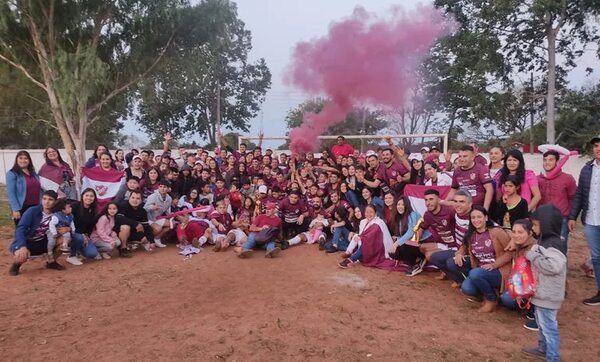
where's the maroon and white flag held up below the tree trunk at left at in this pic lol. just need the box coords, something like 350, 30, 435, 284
81, 167, 125, 210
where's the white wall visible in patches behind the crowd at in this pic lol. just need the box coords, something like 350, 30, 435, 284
0, 150, 590, 184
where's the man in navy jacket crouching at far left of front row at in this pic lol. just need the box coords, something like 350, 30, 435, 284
8, 190, 65, 276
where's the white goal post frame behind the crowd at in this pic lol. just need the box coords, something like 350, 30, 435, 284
238, 133, 449, 153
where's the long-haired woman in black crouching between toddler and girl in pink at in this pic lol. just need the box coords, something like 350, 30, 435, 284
69, 188, 98, 259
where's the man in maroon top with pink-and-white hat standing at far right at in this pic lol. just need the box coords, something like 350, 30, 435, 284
538, 150, 577, 245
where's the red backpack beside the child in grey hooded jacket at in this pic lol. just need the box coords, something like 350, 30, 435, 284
506, 256, 537, 309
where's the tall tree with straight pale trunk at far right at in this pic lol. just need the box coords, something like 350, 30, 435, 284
435, 0, 600, 143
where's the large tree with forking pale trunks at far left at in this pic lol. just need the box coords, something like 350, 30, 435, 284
0, 0, 198, 172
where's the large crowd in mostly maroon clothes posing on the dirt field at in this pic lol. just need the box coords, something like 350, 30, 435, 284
6, 136, 600, 361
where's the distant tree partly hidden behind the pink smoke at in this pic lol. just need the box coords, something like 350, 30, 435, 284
279, 98, 387, 149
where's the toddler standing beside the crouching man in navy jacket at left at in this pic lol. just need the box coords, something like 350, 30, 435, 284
46, 199, 82, 265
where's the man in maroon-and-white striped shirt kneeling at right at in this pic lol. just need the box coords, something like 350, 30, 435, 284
431, 190, 473, 288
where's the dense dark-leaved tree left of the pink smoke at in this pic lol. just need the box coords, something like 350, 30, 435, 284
138, 0, 271, 145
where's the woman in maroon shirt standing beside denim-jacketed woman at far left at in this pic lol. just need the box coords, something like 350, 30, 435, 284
39, 147, 77, 200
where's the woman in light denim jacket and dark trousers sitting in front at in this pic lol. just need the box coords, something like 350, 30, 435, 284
388, 196, 431, 271
